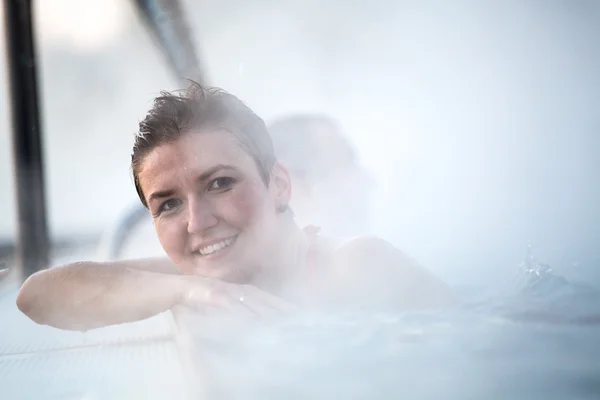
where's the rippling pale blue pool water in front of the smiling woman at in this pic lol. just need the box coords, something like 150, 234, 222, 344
185, 248, 600, 399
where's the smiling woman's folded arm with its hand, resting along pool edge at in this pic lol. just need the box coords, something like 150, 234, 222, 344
17, 258, 294, 331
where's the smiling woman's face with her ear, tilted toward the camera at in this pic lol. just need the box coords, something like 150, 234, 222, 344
138, 130, 290, 283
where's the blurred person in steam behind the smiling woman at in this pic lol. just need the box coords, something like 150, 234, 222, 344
269, 114, 373, 237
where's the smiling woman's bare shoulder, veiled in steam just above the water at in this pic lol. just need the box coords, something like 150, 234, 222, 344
331, 236, 455, 310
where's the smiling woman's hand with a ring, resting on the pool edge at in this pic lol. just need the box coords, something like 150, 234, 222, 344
181, 276, 298, 316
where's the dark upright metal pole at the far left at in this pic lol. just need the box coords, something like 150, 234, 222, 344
4, 0, 50, 280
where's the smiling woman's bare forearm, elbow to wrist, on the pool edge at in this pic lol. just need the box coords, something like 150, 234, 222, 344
17, 262, 183, 331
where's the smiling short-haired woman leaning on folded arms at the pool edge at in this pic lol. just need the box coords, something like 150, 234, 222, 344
17, 84, 453, 331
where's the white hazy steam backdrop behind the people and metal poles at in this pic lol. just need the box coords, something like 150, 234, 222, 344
0, 0, 600, 282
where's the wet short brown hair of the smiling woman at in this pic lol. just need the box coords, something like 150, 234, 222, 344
131, 81, 276, 208
